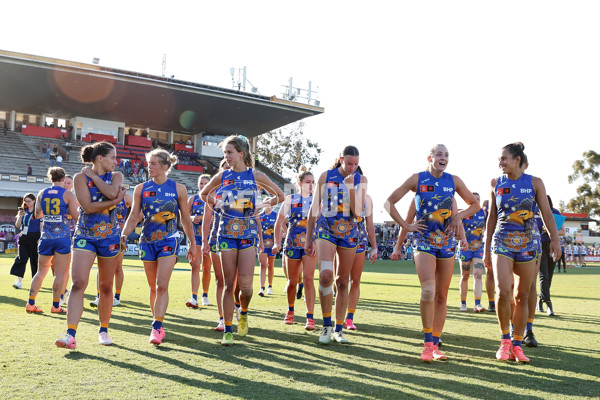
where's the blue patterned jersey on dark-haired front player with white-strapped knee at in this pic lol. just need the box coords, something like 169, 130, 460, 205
318, 168, 360, 241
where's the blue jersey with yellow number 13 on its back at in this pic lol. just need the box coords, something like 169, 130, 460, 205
40, 186, 71, 239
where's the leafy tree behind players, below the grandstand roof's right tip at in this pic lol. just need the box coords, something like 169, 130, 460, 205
256, 121, 323, 182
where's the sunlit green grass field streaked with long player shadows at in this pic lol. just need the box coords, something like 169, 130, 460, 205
0, 255, 600, 399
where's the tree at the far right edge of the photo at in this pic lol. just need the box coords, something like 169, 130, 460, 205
567, 150, 600, 218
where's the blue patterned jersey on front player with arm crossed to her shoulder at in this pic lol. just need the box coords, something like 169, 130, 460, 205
75, 172, 121, 239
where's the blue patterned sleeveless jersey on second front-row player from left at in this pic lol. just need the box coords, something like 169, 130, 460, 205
140, 179, 179, 243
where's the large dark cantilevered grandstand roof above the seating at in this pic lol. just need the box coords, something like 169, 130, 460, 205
0, 50, 324, 137
